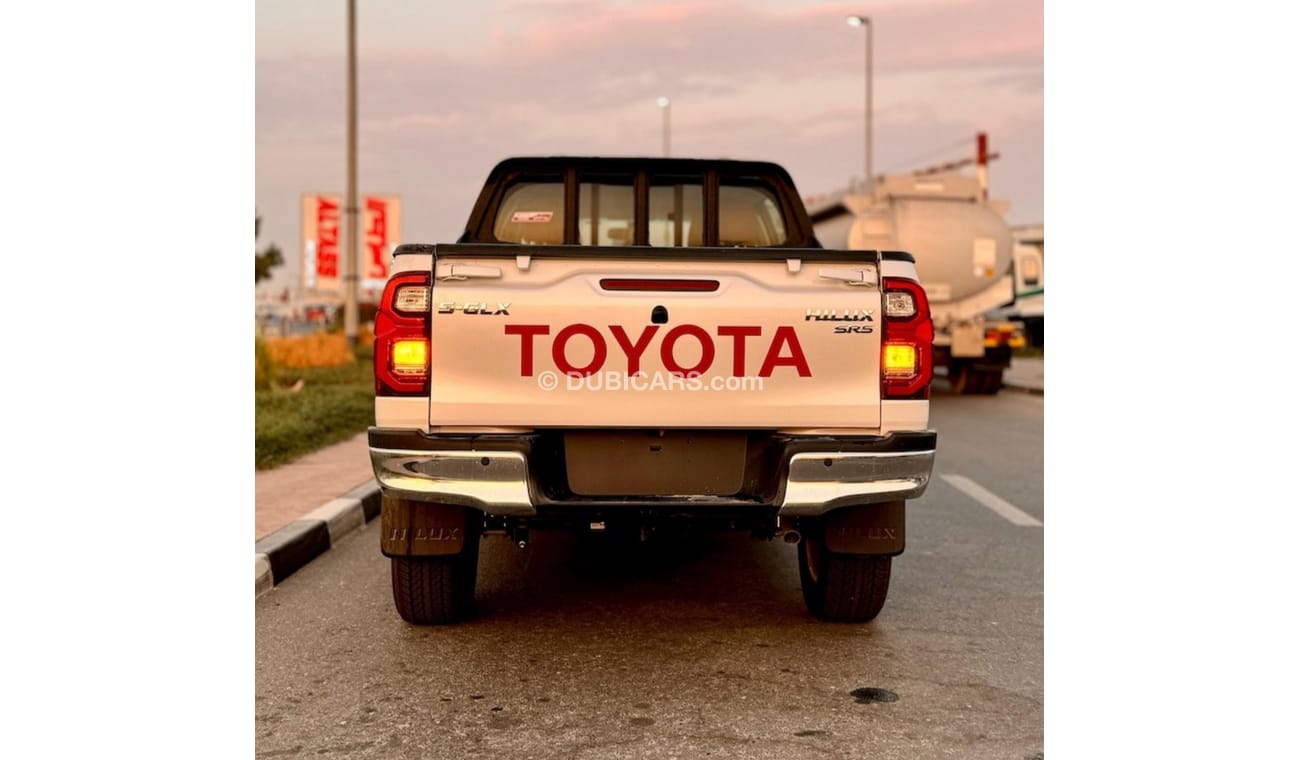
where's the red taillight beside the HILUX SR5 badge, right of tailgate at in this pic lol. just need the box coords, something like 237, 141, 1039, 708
880, 277, 935, 399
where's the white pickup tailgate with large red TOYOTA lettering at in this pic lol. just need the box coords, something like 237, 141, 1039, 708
429, 244, 880, 429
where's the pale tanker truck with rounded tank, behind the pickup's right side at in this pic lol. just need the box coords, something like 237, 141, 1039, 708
805, 174, 1041, 394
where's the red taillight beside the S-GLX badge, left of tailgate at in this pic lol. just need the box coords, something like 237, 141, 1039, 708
374, 272, 432, 396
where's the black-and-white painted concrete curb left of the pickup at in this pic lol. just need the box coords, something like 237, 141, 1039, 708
254, 481, 380, 596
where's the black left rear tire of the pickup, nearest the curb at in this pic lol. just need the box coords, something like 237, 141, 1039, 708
391, 530, 478, 625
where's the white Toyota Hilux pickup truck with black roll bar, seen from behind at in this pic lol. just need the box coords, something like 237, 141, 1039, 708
369, 157, 936, 624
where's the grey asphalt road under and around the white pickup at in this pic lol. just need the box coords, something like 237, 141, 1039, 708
256, 382, 1044, 760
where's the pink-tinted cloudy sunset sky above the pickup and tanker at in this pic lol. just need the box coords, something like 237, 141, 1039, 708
256, 0, 1044, 291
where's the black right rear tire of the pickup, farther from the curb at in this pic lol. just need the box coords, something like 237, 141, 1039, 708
798, 533, 893, 622
